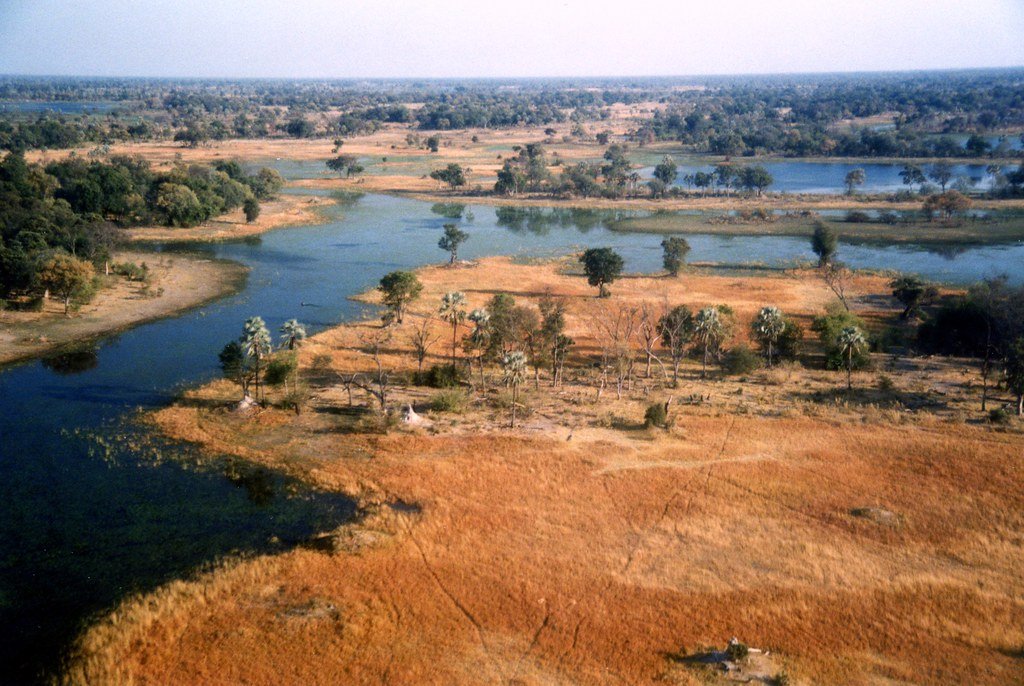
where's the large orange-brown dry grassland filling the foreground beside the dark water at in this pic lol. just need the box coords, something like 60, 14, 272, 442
68, 258, 1024, 684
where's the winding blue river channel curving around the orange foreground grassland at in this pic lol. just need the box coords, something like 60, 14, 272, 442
0, 188, 1024, 683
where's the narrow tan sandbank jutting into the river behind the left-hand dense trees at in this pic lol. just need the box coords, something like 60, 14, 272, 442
125, 195, 334, 243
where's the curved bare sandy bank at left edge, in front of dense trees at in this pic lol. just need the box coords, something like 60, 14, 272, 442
0, 251, 247, 365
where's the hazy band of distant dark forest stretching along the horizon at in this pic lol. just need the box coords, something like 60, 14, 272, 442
0, 70, 1024, 158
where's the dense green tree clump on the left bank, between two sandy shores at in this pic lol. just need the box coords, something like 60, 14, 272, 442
0, 153, 284, 297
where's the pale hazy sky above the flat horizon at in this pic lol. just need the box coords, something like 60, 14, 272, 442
0, 0, 1024, 78
